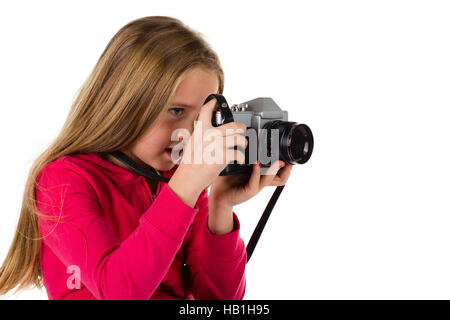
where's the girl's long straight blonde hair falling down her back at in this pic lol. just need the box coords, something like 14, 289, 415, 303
0, 16, 224, 294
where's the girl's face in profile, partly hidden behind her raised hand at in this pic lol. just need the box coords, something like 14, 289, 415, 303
122, 67, 219, 171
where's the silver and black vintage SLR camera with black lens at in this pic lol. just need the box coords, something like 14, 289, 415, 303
205, 94, 314, 176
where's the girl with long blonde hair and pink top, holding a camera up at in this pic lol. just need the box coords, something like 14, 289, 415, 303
0, 16, 292, 299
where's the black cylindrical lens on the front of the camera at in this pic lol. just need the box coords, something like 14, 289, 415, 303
264, 120, 314, 164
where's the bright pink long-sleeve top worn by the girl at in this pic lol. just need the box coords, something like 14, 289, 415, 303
36, 153, 247, 299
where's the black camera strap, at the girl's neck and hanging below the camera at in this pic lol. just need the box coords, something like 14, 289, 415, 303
110, 151, 284, 262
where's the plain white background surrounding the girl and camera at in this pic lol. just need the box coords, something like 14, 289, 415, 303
0, 0, 450, 299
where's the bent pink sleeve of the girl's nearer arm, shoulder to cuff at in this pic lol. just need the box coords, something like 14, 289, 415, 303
36, 167, 198, 299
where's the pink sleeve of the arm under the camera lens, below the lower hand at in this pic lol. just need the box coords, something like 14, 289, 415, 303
185, 191, 247, 300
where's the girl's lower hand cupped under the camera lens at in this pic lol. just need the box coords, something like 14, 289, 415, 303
209, 160, 293, 207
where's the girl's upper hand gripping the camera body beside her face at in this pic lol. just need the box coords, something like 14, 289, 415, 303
168, 99, 248, 207
